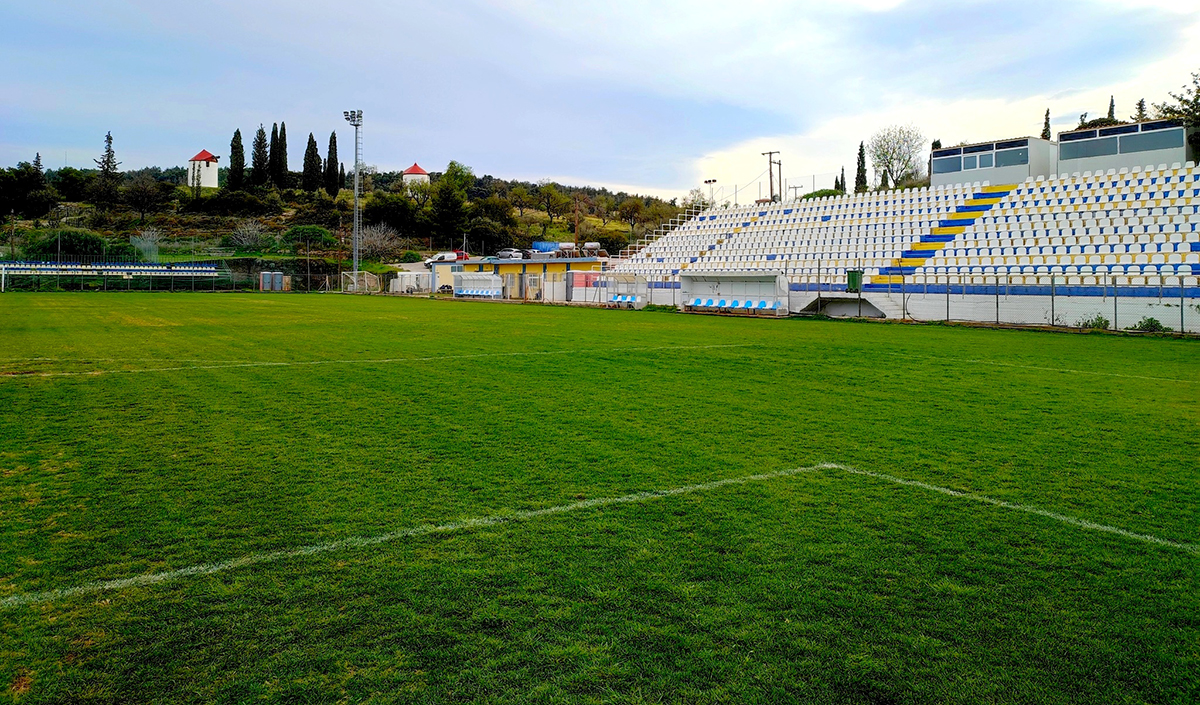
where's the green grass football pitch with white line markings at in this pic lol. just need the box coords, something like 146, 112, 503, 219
0, 294, 1200, 703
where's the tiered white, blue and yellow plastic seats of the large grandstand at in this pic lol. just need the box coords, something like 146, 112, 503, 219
616, 163, 1200, 287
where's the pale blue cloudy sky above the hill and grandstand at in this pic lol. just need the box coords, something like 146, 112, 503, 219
0, 0, 1200, 201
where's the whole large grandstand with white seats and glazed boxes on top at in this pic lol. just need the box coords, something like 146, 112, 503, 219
614, 121, 1200, 326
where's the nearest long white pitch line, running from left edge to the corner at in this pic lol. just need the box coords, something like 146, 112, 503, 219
0, 464, 825, 608
